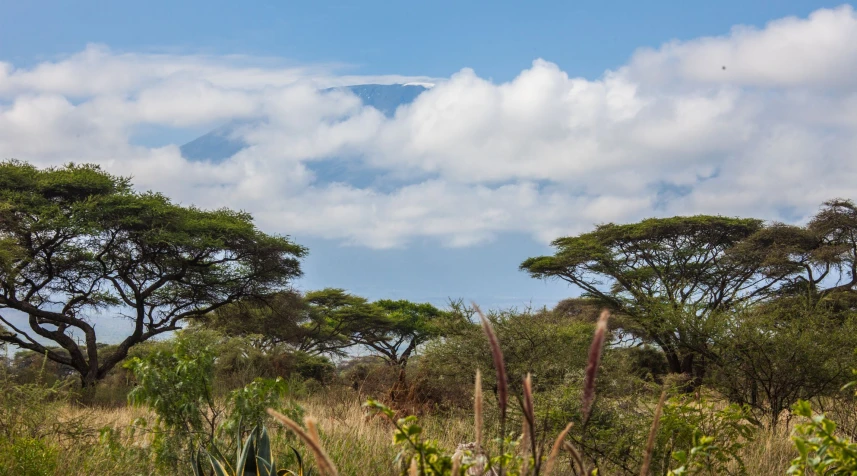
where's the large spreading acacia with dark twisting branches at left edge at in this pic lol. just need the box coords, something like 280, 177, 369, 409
0, 161, 306, 387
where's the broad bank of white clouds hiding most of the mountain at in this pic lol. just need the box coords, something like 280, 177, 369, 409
0, 6, 857, 248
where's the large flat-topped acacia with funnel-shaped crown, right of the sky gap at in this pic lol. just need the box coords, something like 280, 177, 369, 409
521, 215, 794, 383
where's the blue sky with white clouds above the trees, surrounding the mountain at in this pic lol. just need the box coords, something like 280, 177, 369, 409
0, 0, 857, 338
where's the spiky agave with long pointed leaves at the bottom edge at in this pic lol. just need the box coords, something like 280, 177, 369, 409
192, 426, 312, 476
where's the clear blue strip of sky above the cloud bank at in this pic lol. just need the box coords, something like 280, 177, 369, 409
0, 0, 842, 81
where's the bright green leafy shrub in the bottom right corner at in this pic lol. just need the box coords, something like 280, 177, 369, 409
788, 400, 857, 476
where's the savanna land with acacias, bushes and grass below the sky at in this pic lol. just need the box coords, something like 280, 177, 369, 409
0, 161, 857, 476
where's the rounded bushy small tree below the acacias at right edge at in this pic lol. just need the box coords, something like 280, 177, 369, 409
711, 298, 857, 428
